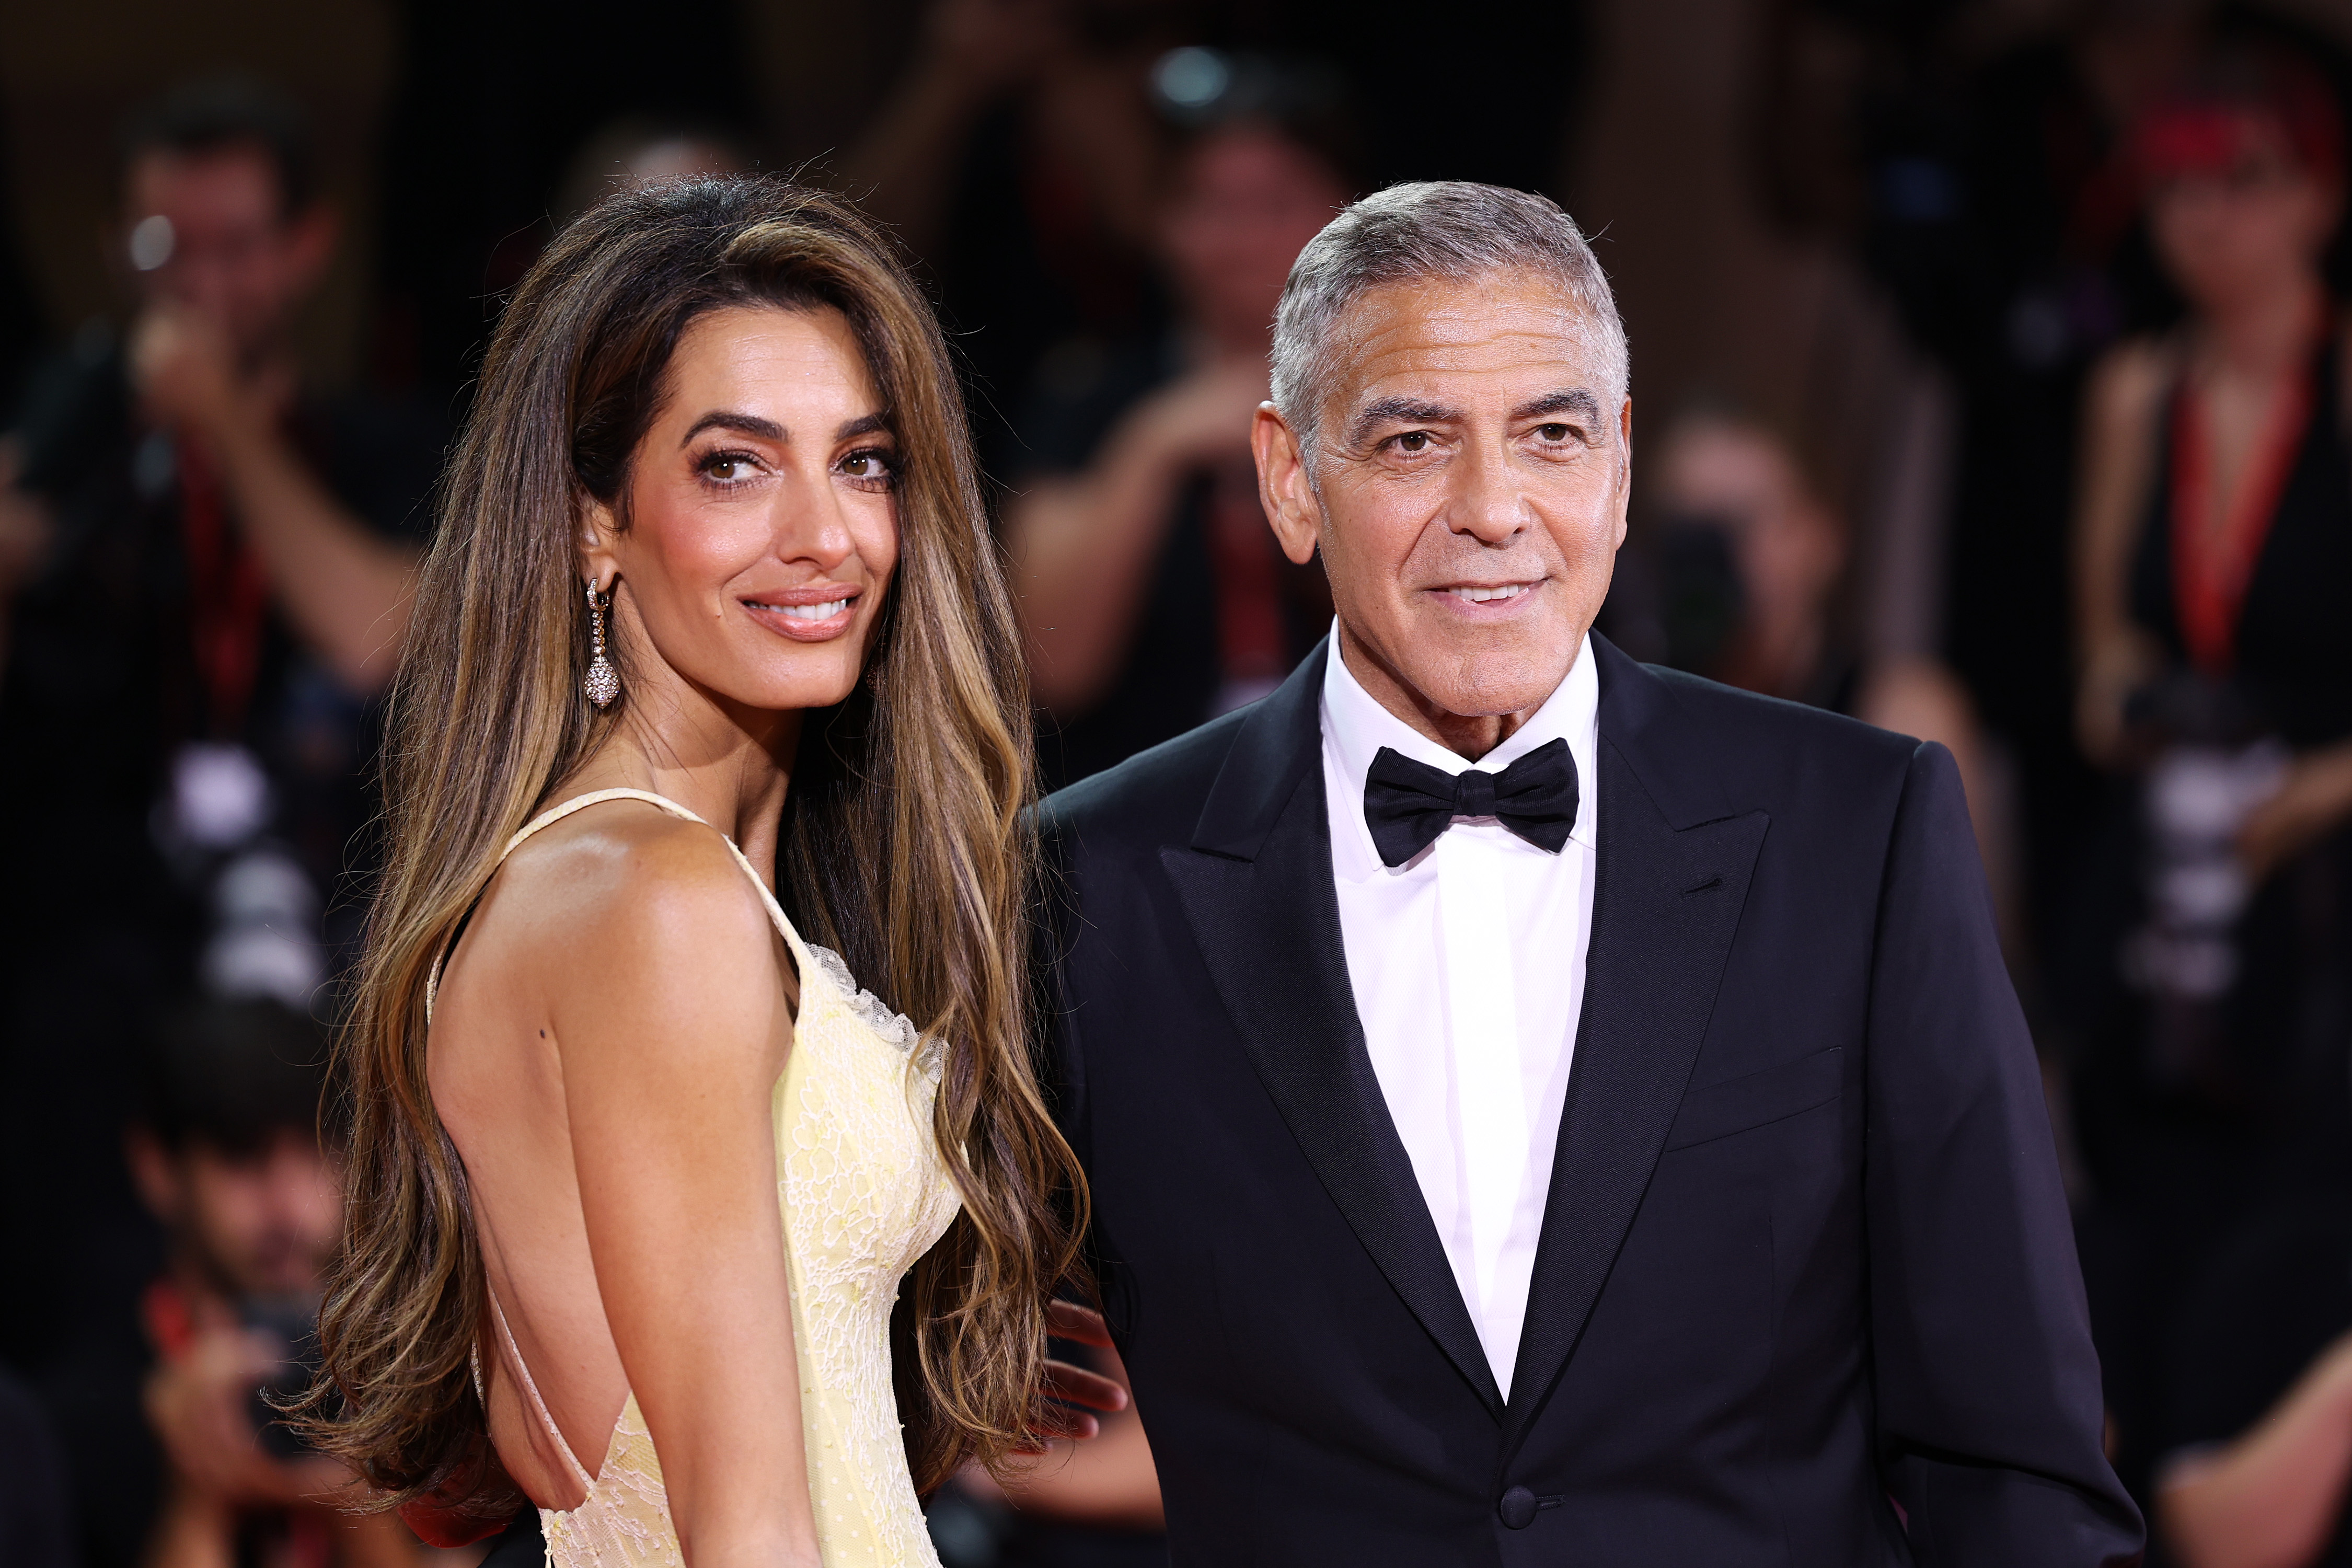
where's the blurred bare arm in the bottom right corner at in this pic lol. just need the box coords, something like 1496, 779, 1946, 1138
2157, 1335, 2352, 1568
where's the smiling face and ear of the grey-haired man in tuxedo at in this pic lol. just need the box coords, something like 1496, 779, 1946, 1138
1259, 273, 1632, 745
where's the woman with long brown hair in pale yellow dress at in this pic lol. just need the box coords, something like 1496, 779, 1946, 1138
292, 179, 1117, 1568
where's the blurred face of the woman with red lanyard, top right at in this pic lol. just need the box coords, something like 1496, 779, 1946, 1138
2150, 120, 2338, 310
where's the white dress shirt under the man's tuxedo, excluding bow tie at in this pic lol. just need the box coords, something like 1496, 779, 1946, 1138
1322, 628, 1599, 1399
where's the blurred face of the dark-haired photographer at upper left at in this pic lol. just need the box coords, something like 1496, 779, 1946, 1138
122, 146, 332, 355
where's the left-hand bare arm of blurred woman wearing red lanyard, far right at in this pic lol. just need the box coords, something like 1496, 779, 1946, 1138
2072, 343, 2176, 762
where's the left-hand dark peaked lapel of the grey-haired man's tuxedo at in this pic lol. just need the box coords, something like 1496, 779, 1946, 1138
1162, 644, 1503, 1415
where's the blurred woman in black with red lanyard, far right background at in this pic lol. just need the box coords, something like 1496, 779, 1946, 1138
2072, 52, 2352, 1483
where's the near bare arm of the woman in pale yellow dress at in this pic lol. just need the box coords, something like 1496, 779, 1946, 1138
548, 823, 818, 1568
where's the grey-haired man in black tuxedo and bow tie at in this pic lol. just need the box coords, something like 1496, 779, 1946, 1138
1044, 183, 2140, 1568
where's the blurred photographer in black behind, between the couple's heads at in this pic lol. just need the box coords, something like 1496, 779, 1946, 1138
1005, 49, 1353, 785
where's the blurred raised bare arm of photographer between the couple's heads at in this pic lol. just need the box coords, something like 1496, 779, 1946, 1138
1005, 360, 1265, 717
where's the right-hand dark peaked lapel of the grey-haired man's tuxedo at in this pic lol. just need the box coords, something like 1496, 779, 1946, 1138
1505, 637, 1769, 1446
